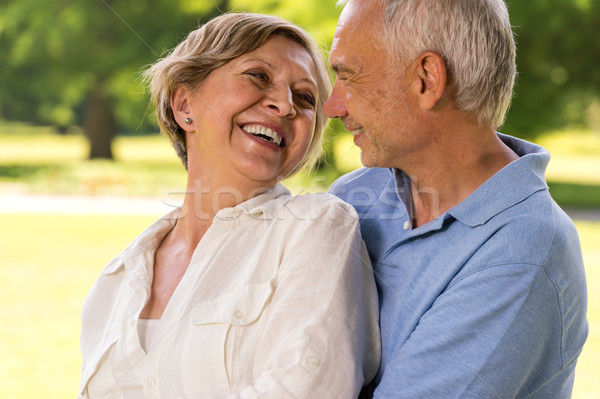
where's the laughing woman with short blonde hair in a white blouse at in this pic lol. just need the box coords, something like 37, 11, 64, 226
80, 14, 380, 399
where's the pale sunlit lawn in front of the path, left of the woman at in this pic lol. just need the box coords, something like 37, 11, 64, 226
0, 214, 154, 399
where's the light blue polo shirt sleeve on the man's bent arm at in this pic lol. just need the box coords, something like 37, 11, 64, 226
374, 263, 576, 399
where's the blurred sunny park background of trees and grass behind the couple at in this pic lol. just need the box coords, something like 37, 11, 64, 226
0, 0, 600, 399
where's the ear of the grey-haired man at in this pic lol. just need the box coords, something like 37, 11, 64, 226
414, 51, 448, 110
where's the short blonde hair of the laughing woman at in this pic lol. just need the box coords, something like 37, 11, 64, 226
144, 13, 331, 173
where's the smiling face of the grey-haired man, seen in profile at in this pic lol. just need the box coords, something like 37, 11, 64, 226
324, 0, 418, 167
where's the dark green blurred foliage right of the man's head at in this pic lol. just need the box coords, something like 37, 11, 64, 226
503, 0, 600, 137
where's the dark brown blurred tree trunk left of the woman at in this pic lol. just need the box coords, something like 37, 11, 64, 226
83, 79, 116, 159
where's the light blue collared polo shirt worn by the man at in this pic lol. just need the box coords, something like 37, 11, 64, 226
330, 134, 588, 399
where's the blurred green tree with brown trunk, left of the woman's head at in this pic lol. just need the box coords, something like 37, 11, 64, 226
0, 0, 228, 158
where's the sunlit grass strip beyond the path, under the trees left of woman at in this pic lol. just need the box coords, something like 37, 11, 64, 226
0, 124, 186, 196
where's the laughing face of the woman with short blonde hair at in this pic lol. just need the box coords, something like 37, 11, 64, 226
183, 36, 318, 188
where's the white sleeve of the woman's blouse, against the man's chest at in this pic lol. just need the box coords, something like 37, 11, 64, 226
228, 197, 380, 399
